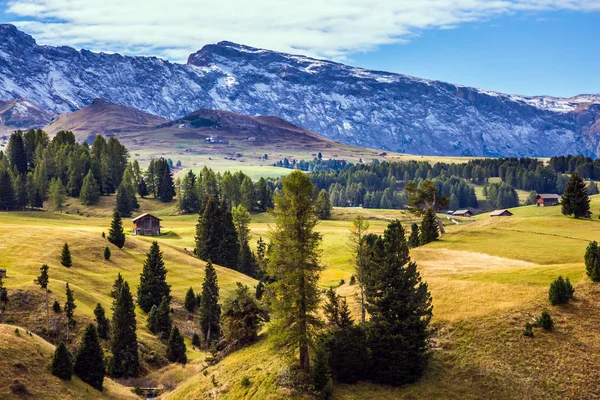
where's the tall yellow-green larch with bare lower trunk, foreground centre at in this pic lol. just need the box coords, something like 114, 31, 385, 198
267, 171, 322, 372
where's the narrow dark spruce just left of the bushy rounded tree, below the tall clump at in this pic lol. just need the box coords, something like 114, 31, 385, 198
199, 260, 221, 344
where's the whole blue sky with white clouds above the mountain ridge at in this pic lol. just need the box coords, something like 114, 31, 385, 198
0, 0, 600, 97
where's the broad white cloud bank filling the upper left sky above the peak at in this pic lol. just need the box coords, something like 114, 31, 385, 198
7, 0, 600, 61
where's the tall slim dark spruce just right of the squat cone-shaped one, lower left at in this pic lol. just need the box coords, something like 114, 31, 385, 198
108, 282, 140, 378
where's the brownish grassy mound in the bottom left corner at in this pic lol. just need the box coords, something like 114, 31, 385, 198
0, 325, 138, 400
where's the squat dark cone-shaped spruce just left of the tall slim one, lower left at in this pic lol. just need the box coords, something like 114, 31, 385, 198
74, 324, 105, 391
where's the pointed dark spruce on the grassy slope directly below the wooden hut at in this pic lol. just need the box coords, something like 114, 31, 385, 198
137, 241, 171, 312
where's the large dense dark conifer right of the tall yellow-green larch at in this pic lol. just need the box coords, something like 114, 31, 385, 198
366, 221, 432, 385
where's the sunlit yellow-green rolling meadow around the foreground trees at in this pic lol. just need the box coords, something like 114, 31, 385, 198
0, 196, 600, 399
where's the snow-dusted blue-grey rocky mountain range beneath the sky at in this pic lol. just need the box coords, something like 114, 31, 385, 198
0, 24, 600, 157
